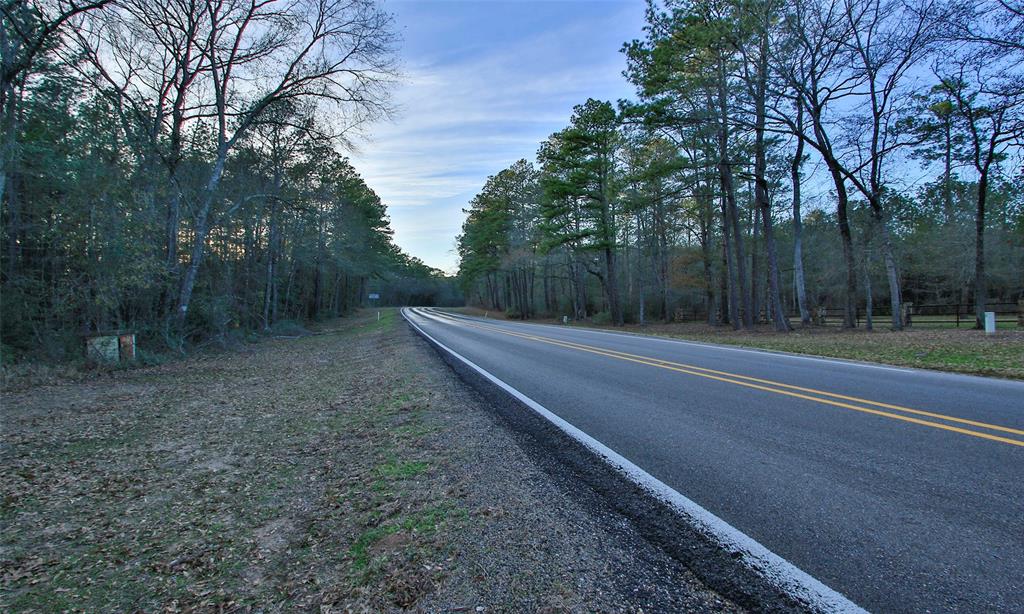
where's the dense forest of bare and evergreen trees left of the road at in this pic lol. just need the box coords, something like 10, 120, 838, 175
0, 0, 454, 360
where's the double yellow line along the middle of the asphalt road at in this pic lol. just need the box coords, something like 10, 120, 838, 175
421, 311, 1024, 447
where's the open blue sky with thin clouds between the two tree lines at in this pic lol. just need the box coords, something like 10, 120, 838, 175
349, 0, 644, 273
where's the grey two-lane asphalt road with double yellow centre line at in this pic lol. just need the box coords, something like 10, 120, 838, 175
409, 310, 1024, 612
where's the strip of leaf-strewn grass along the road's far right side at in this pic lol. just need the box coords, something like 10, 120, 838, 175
461, 308, 1024, 380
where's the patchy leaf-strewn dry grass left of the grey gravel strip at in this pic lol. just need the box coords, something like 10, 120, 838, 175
0, 312, 465, 612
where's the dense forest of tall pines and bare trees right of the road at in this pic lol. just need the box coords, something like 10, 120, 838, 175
459, 0, 1024, 331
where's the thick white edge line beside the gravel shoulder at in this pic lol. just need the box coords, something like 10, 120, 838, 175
401, 308, 865, 612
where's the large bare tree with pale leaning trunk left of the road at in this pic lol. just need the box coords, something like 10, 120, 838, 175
74, 0, 395, 335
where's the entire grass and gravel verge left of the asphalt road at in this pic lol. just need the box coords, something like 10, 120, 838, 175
0, 311, 738, 612
